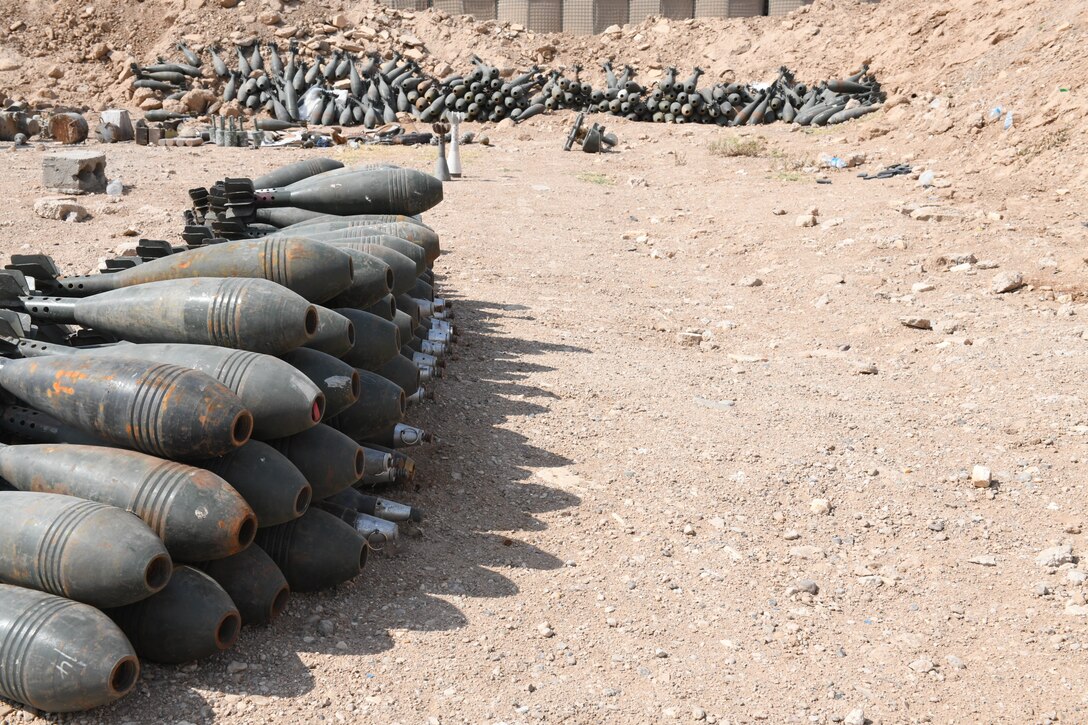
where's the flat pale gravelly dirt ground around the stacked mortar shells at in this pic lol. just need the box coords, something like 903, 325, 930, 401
0, 109, 1088, 725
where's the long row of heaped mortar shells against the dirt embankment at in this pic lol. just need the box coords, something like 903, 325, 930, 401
133, 38, 886, 131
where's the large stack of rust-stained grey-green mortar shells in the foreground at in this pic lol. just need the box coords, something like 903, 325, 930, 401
0, 159, 456, 712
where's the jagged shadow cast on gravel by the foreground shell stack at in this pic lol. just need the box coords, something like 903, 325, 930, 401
83, 289, 588, 723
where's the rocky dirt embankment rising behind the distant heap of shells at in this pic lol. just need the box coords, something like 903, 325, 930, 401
0, 0, 1088, 188
